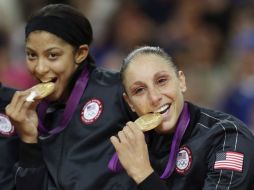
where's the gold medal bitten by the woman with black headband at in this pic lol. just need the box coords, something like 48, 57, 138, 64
26, 82, 55, 102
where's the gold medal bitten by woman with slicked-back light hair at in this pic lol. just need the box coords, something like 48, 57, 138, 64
134, 113, 162, 131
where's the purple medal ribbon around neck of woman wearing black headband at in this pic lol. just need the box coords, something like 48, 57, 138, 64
38, 68, 89, 135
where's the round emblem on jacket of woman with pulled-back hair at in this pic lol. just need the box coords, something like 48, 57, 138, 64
176, 146, 192, 174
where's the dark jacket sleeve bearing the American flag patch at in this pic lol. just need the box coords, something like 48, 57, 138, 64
203, 121, 254, 190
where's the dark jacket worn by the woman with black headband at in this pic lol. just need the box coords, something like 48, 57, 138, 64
15, 68, 136, 190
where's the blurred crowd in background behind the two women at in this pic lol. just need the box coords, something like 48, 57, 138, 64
0, 0, 254, 131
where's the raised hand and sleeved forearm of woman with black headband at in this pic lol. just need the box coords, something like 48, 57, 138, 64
5, 91, 48, 190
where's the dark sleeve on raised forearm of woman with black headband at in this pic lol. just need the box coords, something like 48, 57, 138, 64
14, 142, 49, 190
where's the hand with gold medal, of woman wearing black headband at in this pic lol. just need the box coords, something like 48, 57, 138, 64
5, 82, 55, 143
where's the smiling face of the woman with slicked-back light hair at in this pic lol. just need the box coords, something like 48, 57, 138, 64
123, 54, 186, 133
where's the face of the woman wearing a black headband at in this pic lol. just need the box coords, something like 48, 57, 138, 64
26, 31, 78, 100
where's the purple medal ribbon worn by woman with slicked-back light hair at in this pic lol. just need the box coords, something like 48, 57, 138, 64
108, 103, 190, 179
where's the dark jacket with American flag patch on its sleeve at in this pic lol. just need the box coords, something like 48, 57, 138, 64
139, 103, 254, 190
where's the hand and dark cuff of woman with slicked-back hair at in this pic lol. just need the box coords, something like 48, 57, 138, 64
110, 122, 167, 190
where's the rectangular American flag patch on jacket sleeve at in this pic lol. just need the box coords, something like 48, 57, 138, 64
214, 151, 244, 172
